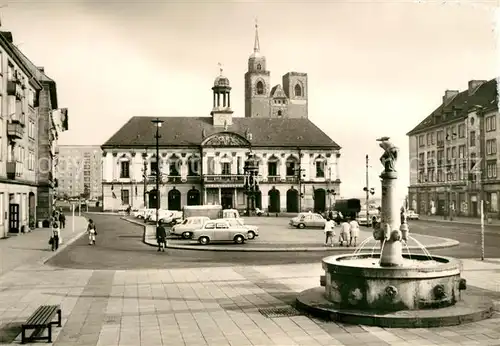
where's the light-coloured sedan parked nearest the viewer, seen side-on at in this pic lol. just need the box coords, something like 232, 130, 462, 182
191, 220, 248, 245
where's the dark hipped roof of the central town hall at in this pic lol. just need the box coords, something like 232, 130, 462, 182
102, 117, 340, 149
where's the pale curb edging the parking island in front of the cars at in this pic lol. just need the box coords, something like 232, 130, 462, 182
121, 217, 460, 252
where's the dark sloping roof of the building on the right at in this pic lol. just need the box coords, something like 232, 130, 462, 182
406, 79, 498, 136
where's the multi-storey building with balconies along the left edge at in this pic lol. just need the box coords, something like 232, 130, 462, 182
0, 32, 68, 235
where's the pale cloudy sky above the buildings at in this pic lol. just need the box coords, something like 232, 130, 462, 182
0, 0, 500, 197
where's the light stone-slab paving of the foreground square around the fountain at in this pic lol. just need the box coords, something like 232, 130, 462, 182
0, 260, 500, 346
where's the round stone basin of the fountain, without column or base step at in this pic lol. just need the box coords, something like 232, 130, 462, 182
323, 253, 465, 313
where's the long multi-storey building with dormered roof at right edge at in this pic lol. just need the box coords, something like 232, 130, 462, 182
407, 79, 500, 216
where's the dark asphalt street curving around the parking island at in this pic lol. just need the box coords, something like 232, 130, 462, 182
47, 214, 500, 270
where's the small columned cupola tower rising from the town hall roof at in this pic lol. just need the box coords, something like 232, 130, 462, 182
210, 64, 233, 127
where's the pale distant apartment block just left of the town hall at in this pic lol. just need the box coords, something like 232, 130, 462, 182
56, 145, 102, 199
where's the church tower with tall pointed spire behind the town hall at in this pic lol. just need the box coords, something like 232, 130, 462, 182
245, 23, 271, 118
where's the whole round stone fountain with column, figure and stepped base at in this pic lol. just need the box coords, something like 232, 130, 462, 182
296, 137, 493, 327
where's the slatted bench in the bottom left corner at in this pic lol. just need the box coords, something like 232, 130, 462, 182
21, 305, 61, 344
